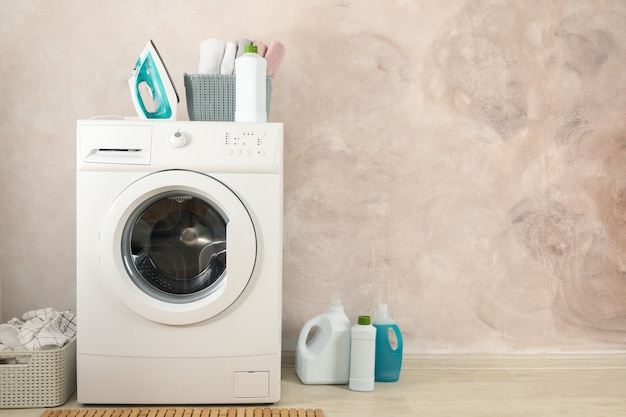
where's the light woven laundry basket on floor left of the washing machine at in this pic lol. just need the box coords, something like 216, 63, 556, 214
0, 338, 76, 408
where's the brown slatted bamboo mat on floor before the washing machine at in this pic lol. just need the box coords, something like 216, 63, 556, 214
41, 407, 324, 417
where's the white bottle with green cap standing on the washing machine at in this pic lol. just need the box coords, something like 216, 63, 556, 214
235, 45, 267, 123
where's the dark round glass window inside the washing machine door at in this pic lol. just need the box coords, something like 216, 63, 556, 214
122, 192, 227, 303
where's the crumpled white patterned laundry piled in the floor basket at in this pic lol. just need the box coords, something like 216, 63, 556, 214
0, 308, 76, 363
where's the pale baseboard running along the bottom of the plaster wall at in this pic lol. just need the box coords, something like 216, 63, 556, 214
282, 351, 626, 369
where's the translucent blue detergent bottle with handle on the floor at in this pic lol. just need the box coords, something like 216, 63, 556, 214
373, 304, 402, 382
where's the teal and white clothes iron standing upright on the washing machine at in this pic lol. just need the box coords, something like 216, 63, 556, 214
128, 40, 179, 120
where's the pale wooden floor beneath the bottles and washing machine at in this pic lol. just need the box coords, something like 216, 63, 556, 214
0, 354, 626, 417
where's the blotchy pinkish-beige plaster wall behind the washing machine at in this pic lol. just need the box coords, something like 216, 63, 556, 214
0, 0, 626, 353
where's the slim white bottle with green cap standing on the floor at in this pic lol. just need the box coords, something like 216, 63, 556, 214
348, 316, 376, 391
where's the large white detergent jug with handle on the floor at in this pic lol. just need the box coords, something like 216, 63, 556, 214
296, 299, 352, 384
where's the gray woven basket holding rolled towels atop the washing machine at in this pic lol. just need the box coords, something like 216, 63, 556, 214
185, 74, 272, 122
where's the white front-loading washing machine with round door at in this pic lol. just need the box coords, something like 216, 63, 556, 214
76, 120, 283, 404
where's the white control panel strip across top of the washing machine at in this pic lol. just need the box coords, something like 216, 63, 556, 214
78, 120, 283, 172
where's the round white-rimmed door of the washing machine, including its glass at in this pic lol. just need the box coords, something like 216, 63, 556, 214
99, 170, 257, 325
